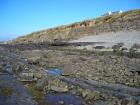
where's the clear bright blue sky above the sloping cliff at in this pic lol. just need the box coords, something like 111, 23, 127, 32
0, 0, 140, 40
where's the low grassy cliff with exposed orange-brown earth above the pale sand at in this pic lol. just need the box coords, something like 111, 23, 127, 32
13, 10, 140, 43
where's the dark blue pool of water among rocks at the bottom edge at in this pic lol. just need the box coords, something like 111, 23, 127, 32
45, 93, 84, 105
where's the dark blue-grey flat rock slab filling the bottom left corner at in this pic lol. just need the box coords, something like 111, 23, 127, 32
0, 74, 37, 105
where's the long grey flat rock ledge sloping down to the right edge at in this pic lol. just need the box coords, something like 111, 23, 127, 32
60, 77, 140, 102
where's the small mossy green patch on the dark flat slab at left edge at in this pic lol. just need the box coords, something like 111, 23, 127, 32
0, 87, 13, 96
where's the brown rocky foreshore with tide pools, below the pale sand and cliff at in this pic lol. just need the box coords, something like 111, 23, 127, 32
0, 45, 140, 105
